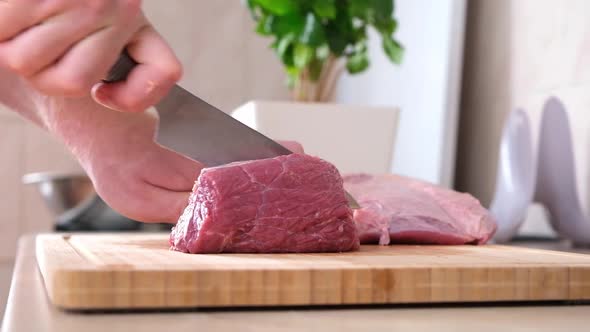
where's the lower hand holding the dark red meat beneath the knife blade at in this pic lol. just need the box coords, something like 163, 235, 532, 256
38, 93, 203, 223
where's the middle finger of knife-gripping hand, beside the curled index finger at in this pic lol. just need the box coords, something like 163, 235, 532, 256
29, 23, 136, 96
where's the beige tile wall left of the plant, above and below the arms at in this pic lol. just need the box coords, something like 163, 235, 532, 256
0, 0, 288, 260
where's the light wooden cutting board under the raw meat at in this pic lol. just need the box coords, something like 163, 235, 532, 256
36, 234, 590, 309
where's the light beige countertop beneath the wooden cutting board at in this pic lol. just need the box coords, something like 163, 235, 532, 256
2, 236, 590, 332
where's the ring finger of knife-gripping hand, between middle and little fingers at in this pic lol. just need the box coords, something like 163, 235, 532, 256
0, 12, 101, 77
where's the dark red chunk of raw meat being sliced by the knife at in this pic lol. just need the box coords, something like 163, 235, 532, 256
170, 154, 359, 253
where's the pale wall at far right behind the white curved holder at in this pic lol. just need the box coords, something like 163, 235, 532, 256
456, 0, 590, 233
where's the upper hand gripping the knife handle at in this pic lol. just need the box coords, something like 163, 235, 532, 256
0, 0, 181, 112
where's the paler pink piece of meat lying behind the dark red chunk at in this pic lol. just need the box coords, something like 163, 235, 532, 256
344, 174, 496, 245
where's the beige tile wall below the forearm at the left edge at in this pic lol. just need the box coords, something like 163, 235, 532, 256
0, 107, 80, 261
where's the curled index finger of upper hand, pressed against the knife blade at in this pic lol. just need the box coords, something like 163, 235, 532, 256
92, 26, 182, 112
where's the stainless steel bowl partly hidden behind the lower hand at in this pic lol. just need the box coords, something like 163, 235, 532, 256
22, 172, 96, 216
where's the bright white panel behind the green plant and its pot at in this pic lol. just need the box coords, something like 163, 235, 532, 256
336, 0, 465, 186
